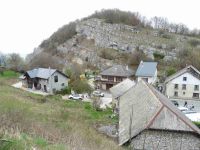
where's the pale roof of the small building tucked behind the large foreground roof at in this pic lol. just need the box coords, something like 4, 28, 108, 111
110, 78, 135, 98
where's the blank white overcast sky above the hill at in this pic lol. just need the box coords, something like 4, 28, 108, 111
0, 0, 200, 56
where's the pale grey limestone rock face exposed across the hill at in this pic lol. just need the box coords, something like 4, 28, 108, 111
28, 18, 193, 69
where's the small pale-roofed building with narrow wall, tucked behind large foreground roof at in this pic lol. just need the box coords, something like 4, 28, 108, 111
110, 78, 135, 114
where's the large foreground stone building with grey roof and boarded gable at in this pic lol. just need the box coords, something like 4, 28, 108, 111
118, 80, 200, 150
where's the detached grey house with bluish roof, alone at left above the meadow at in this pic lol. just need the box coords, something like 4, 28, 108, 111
21, 68, 69, 93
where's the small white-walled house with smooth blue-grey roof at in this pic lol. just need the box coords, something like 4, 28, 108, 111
135, 61, 157, 84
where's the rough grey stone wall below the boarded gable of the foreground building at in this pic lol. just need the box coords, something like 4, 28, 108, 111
131, 130, 200, 150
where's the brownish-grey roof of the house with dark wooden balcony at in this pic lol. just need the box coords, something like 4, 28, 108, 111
100, 65, 134, 77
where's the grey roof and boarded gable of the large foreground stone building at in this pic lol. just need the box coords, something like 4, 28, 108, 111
119, 81, 200, 145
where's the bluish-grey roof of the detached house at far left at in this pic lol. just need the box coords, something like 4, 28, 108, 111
25, 68, 67, 79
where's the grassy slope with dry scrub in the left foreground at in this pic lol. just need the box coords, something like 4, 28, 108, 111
0, 73, 121, 150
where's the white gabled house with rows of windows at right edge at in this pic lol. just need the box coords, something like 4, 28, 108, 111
165, 65, 200, 99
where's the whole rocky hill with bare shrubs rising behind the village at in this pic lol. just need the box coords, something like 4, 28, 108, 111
27, 10, 200, 73
